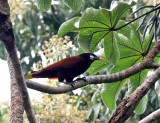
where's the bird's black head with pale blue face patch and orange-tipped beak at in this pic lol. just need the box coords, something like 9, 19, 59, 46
81, 53, 104, 61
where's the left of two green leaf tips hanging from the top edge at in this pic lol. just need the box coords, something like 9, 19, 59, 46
35, 0, 51, 11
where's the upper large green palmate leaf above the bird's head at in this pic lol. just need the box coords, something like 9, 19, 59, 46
58, 1, 135, 64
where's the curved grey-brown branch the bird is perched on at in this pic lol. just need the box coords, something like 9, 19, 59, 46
26, 40, 160, 94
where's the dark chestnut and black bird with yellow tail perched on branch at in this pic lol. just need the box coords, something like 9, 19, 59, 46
25, 53, 105, 86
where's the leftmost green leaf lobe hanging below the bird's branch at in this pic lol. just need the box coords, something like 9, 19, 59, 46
101, 79, 127, 110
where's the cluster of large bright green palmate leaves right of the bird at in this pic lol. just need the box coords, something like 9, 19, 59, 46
58, 1, 160, 114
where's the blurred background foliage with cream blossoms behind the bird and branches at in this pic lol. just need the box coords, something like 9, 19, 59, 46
0, 0, 160, 123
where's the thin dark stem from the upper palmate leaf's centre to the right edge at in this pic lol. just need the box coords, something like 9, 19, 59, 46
113, 6, 160, 31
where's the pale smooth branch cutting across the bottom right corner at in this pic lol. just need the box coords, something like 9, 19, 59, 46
138, 109, 160, 123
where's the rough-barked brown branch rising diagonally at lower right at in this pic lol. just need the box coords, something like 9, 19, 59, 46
108, 68, 160, 123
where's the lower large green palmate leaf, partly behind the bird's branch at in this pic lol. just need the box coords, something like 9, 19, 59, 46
102, 22, 151, 114
